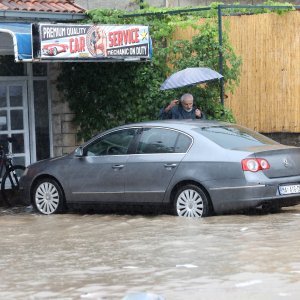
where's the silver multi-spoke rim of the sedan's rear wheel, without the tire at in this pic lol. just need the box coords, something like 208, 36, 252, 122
176, 189, 203, 218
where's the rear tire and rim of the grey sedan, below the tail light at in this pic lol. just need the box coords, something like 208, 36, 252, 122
173, 184, 211, 218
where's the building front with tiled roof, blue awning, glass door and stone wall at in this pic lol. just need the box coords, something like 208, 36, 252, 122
0, 0, 86, 165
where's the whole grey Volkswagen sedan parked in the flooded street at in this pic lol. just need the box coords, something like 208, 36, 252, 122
20, 120, 300, 217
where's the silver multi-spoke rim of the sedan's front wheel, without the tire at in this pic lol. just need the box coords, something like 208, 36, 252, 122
35, 182, 59, 215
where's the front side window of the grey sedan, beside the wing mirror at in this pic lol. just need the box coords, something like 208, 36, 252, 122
84, 129, 137, 156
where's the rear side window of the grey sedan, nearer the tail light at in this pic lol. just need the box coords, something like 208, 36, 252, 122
137, 128, 191, 154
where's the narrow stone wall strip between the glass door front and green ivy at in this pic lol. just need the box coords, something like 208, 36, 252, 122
49, 63, 81, 156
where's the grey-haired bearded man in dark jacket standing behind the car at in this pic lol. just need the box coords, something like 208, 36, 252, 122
159, 94, 205, 120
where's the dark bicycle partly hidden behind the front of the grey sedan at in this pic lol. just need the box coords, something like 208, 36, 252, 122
0, 138, 25, 206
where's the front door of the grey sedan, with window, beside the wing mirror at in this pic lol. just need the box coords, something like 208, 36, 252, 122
69, 129, 137, 202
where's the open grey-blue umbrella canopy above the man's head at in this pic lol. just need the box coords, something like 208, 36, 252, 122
160, 68, 223, 90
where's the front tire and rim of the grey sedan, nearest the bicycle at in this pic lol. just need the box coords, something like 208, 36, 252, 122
32, 178, 65, 215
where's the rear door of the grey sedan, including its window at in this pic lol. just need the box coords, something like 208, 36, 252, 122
125, 127, 192, 203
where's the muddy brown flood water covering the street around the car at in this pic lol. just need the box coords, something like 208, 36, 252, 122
0, 206, 300, 300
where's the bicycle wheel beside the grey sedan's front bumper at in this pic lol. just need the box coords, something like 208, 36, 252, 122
1, 165, 25, 206
